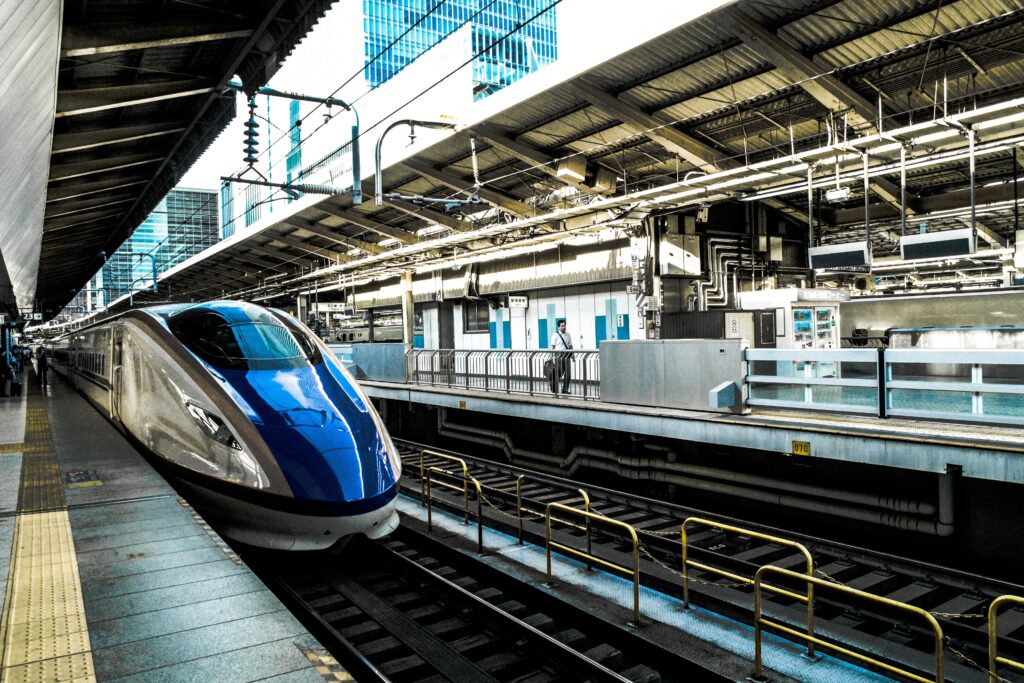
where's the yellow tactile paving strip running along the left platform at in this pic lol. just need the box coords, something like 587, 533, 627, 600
0, 387, 96, 683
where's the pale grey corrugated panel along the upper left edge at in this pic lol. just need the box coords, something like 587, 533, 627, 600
0, 0, 60, 308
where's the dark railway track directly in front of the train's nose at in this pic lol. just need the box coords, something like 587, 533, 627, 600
254, 528, 727, 683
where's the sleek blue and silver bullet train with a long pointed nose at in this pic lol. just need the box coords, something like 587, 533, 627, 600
50, 301, 401, 550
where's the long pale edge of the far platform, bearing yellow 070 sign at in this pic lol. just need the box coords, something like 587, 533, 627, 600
360, 380, 1024, 482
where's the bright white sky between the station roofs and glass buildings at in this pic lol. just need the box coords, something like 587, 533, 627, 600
178, 0, 730, 189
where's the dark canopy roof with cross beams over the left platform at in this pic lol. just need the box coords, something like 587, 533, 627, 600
0, 0, 332, 314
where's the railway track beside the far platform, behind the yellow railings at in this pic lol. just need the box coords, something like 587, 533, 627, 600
398, 441, 1024, 682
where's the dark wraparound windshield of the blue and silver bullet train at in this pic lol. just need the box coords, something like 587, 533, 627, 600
168, 309, 321, 370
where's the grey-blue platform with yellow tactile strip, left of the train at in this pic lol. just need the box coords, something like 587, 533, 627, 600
0, 367, 351, 683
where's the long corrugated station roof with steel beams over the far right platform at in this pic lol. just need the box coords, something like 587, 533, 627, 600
58, 0, 1024, 317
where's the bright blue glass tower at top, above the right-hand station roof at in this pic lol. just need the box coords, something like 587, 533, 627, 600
362, 0, 558, 99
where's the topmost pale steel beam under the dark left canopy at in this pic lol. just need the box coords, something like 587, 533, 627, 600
60, 23, 253, 57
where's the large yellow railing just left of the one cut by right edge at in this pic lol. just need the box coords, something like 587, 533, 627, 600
754, 564, 943, 683
